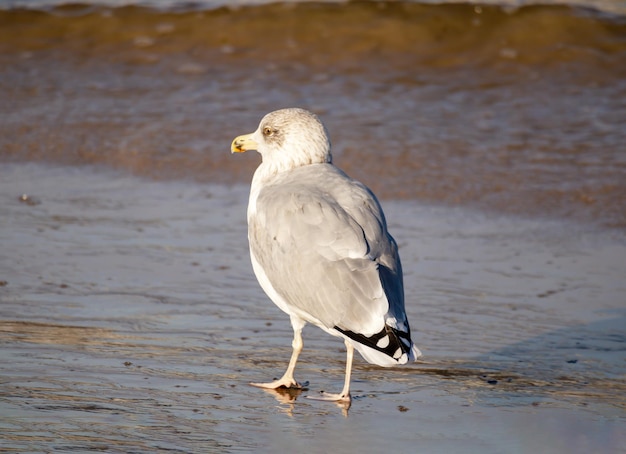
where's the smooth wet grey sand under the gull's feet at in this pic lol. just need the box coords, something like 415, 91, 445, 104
0, 164, 626, 454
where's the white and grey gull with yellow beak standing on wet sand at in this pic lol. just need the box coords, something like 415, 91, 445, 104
231, 109, 421, 402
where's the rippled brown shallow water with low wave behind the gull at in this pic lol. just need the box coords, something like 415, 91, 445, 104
0, 2, 626, 228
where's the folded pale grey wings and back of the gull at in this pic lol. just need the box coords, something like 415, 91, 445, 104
249, 164, 410, 340
